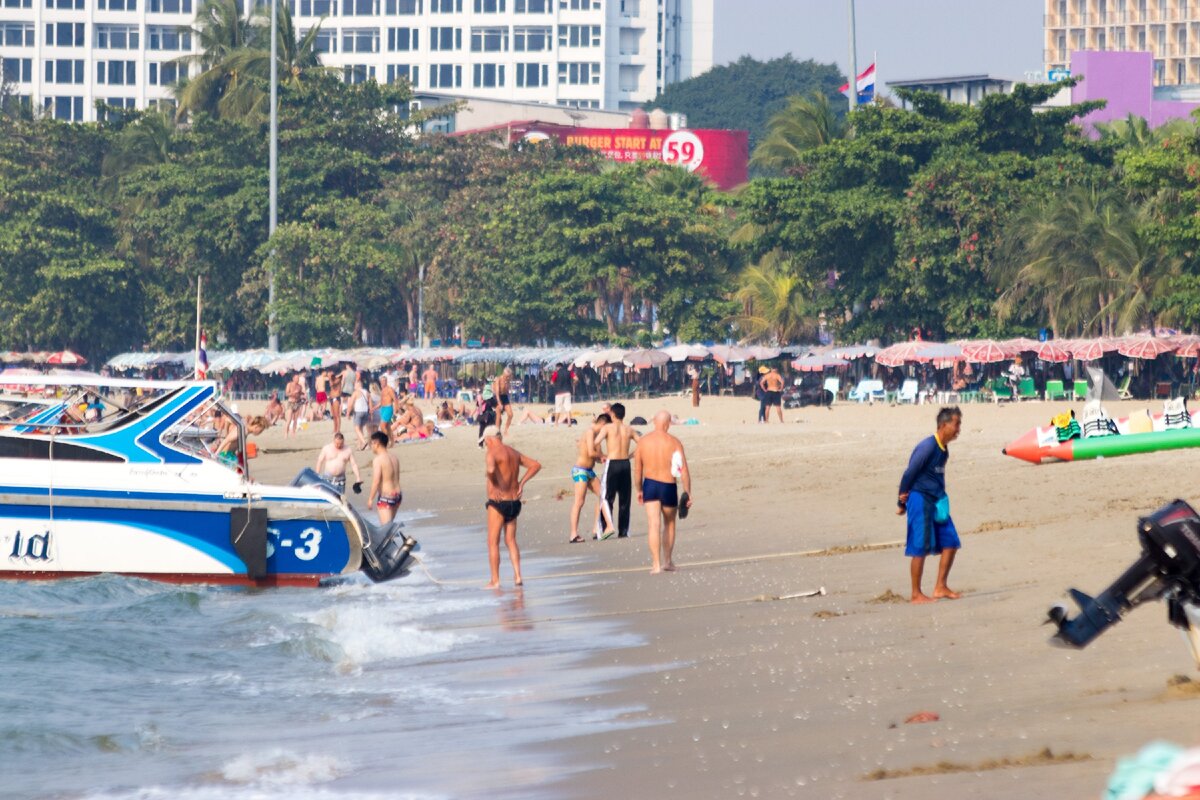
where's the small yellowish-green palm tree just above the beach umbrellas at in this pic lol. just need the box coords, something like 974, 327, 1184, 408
728, 249, 817, 344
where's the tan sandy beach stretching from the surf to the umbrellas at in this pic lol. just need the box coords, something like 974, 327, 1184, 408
246, 397, 1200, 800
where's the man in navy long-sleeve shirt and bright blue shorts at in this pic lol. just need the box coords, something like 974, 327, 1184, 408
896, 405, 962, 603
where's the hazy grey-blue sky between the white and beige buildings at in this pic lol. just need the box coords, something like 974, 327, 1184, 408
714, 0, 1045, 83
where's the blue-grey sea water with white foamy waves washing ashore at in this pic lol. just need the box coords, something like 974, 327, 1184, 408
0, 517, 641, 800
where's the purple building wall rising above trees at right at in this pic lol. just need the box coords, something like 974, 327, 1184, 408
1070, 50, 1200, 134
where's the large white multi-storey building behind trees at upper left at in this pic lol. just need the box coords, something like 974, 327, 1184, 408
0, 0, 713, 121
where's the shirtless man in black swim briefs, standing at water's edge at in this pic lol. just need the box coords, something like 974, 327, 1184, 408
479, 425, 541, 589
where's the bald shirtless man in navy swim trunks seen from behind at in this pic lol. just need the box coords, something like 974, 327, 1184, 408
634, 411, 691, 575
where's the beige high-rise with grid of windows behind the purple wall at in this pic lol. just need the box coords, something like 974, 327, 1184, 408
1044, 0, 1200, 86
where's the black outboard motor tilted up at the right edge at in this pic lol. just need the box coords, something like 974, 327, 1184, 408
1049, 500, 1200, 648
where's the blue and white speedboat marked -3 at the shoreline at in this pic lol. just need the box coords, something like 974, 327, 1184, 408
0, 373, 416, 587
